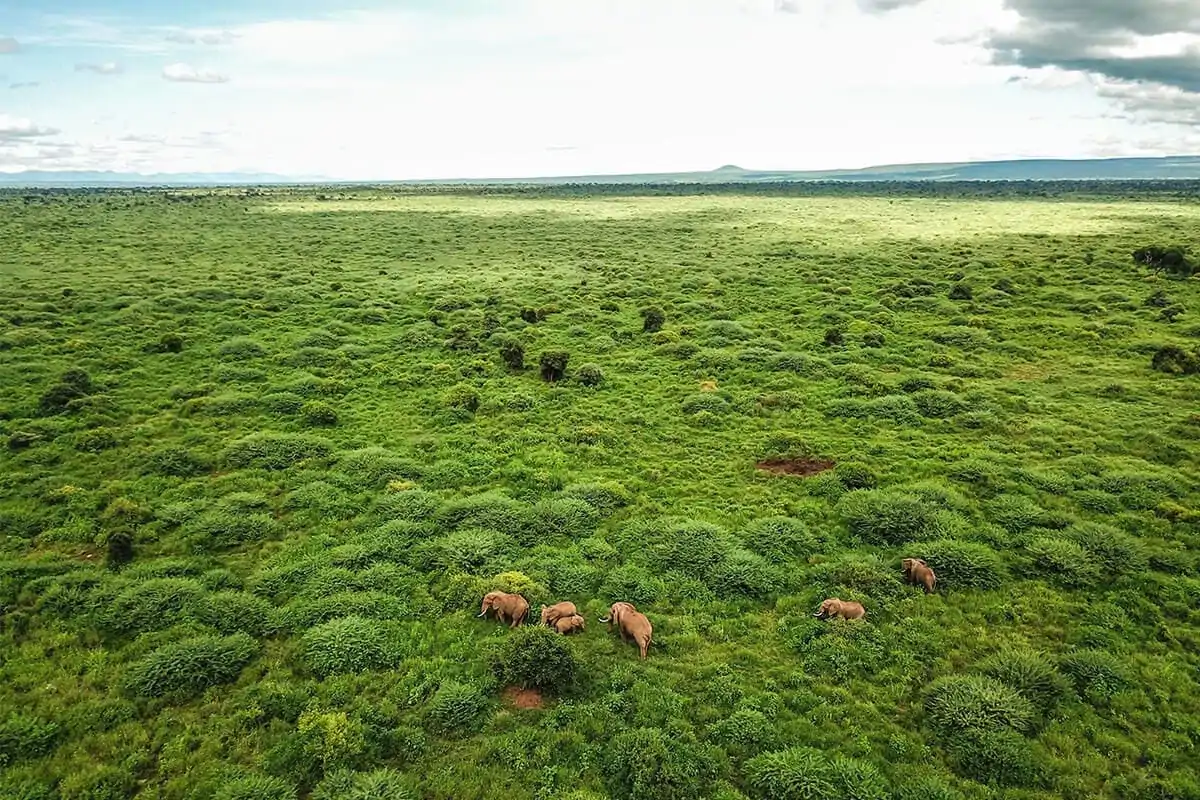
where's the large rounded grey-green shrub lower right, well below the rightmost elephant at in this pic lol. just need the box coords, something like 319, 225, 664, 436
925, 675, 1034, 740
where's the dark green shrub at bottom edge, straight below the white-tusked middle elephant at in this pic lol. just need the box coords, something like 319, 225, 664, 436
601, 728, 716, 800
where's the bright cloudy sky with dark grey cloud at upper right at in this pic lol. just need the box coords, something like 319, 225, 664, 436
0, 0, 1200, 179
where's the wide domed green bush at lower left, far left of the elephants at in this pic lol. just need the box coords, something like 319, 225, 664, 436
125, 633, 258, 699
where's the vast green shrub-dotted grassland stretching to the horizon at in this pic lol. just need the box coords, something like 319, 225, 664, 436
0, 187, 1200, 800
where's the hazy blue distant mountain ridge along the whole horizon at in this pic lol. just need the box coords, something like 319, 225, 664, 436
0, 156, 1200, 187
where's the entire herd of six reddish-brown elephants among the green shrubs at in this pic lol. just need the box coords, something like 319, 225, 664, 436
479, 558, 937, 660
